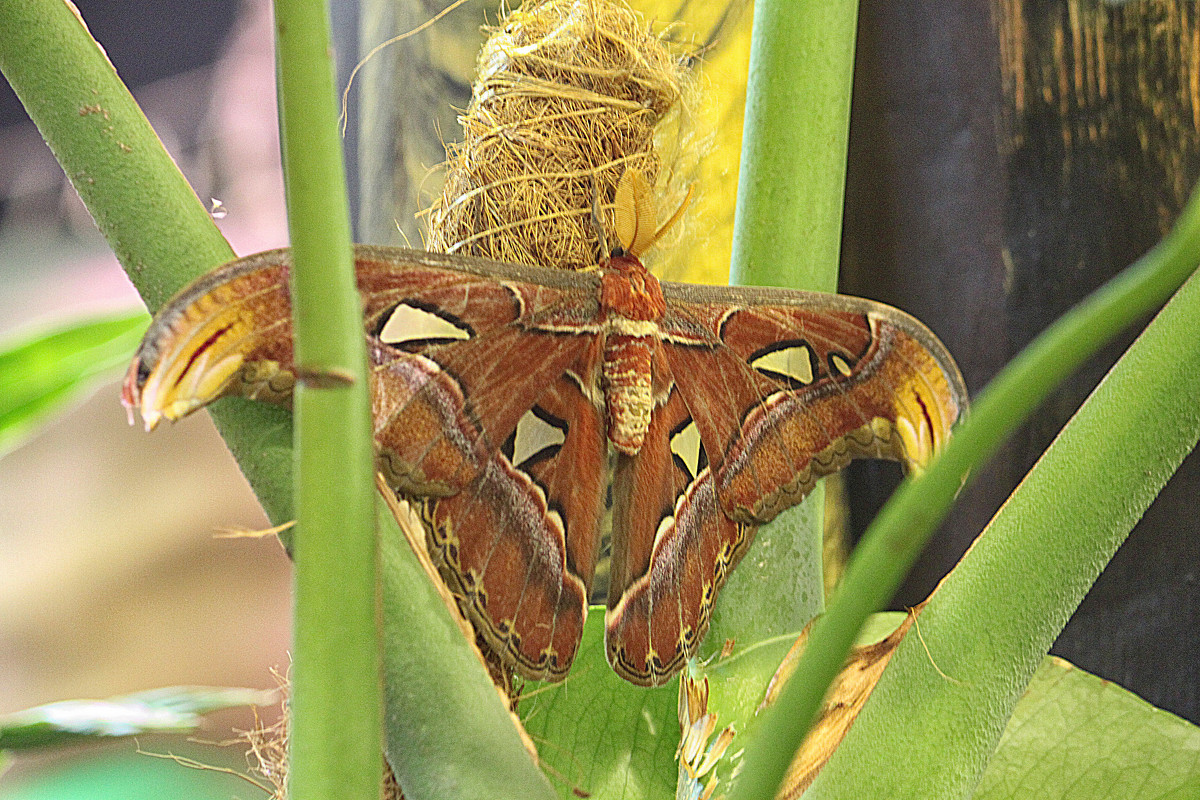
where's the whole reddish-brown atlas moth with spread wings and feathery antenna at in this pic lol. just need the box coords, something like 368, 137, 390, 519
122, 172, 966, 686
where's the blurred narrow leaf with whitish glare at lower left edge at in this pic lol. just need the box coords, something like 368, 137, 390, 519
0, 686, 276, 750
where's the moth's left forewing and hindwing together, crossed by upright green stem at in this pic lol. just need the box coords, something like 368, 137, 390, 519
124, 247, 606, 679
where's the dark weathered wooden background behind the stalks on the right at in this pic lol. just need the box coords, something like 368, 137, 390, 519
841, 0, 1200, 722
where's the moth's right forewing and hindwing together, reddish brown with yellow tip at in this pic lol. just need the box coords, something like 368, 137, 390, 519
606, 283, 966, 685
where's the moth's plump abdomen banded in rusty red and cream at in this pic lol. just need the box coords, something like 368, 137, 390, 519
604, 333, 654, 456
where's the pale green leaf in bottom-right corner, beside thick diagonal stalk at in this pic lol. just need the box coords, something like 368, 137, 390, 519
972, 657, 1200, 800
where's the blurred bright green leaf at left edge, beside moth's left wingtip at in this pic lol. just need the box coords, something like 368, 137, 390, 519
0, 312, 150, 457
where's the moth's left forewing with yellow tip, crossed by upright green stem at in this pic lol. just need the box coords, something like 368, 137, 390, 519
122, 246, 595, 495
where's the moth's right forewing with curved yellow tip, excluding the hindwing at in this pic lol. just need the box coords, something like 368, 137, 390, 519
662, 284, 967, 523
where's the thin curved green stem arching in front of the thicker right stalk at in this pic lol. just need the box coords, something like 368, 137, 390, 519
730, 170, 1200, 800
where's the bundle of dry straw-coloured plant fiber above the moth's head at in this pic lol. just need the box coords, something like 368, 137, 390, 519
427, 0, 690, 269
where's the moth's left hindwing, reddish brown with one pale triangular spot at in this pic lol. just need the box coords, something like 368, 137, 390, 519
425, 367, 607, 680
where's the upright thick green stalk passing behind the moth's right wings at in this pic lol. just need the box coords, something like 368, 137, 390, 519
708, 0, 858, 646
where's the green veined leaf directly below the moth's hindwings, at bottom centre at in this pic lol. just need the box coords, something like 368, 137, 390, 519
520, 607, 679, 800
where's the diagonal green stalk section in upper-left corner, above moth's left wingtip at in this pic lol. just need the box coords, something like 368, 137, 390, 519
0, 0, 233, 311
